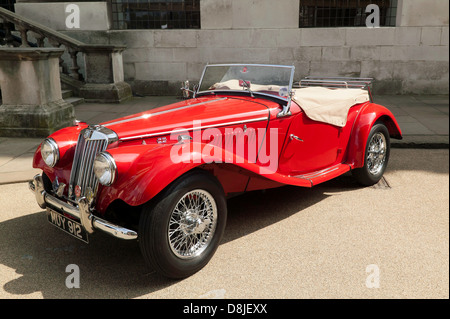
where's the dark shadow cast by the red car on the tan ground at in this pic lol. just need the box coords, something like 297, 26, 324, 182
0, 177, 358, 299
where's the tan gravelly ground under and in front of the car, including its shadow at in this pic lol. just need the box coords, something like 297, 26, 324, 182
0, 149, 449, 299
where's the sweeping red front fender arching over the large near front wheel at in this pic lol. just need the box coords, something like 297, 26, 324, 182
96, 142, 311, 213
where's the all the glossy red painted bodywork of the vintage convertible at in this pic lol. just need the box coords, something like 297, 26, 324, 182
33, 95, 401, 214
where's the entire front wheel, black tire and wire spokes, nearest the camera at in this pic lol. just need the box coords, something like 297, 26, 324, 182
139, 171, 227, 279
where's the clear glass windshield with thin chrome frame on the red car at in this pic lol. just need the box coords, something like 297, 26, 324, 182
197, 64, 294, 100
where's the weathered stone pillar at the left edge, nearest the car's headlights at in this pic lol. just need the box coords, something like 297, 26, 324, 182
0, 48, 75, 137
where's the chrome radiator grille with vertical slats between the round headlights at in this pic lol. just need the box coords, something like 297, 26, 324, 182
69, 126, 116, 199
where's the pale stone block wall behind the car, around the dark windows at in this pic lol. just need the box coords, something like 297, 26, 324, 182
14, 0, 449, 95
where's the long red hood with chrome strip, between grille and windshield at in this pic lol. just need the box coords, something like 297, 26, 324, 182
101, 96, 270, 140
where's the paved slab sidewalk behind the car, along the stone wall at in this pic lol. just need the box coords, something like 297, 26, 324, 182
0, 95, 449, 185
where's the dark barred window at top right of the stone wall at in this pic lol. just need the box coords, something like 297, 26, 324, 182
299, 0, 398, 28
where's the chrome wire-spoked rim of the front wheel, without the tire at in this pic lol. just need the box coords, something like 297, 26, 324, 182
167, 189, 217, 259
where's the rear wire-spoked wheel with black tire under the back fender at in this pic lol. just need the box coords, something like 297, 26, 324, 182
352, 123, 391, 186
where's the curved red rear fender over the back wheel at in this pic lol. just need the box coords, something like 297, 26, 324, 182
346, 103, 403, 169
